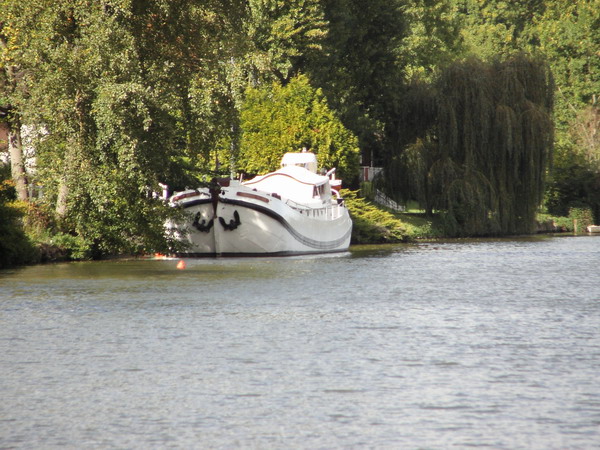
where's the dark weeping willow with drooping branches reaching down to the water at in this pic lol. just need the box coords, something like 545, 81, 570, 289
386, 54, 554, 236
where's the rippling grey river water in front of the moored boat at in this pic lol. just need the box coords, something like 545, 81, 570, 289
0, 236, 600, 449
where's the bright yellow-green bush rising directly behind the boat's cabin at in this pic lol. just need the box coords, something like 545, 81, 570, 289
238, 75, 358, 180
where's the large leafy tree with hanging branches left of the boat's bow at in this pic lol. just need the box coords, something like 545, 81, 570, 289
2, 0, 248, 254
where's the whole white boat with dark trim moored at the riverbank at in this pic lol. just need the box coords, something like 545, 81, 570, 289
167, 152, 352, 256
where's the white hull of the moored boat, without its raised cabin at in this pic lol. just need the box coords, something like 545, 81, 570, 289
166, 183, 352, 256
